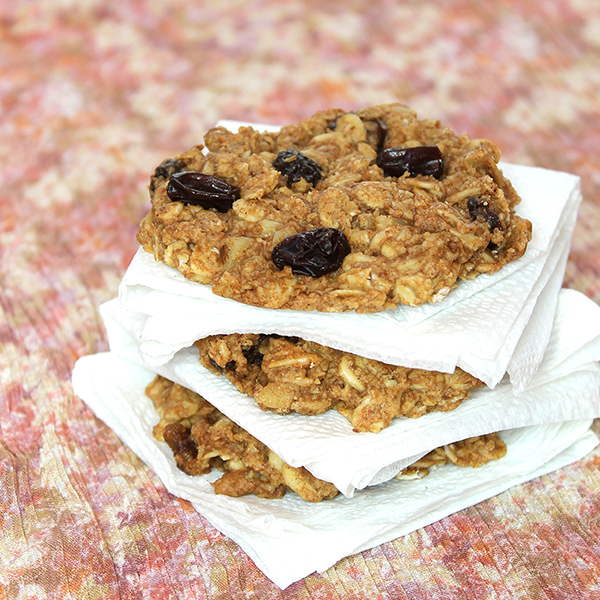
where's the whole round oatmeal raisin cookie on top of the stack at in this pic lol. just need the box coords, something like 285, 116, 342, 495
137, 104, 531, 312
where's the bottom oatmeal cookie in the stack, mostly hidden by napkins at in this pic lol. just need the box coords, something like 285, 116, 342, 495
146, 376, 506, 502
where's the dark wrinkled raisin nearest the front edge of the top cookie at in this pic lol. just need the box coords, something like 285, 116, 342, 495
271, 227, 350, 277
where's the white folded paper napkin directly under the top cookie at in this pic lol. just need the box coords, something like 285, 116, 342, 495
119, 164, 581, 390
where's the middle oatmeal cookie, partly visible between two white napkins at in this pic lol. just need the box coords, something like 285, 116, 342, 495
195, 333, 483, 433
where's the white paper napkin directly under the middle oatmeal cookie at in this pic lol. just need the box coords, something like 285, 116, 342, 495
100, 290, 600, 497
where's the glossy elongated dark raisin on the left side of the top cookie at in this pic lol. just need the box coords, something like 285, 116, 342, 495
167, 171, 240, 212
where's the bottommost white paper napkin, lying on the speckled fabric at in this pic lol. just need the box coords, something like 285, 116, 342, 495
73, 353, 598, 588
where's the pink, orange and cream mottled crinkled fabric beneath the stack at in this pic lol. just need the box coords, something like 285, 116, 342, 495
0, 0, 600, 600
